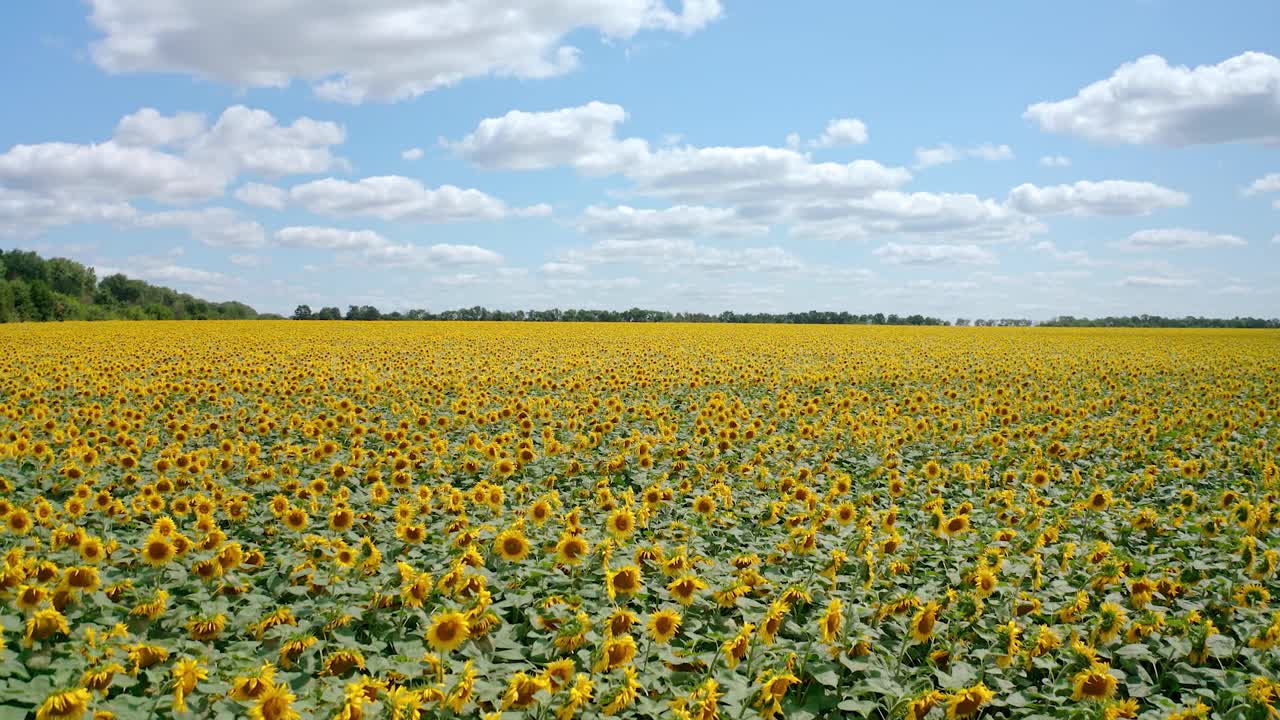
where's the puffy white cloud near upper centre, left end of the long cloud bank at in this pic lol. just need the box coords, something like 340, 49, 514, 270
444, 101, 649, 174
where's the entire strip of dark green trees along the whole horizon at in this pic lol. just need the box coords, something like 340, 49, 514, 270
0, 250, 1280, 328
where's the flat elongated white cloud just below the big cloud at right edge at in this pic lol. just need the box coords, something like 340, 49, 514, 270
1009, 181, 1189, 215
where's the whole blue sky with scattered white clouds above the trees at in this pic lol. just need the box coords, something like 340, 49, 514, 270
0, 0, 1280, 318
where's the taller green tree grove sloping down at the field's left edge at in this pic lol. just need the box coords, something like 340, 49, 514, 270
0, 250, 262, 323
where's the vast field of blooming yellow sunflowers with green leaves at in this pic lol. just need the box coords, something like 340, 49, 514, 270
0, 322, 1280, 720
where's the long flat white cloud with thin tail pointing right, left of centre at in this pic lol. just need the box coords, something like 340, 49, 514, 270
289, 176, 550, 223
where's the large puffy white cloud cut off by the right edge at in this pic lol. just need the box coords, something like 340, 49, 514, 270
1024, 53, 1280, 146
